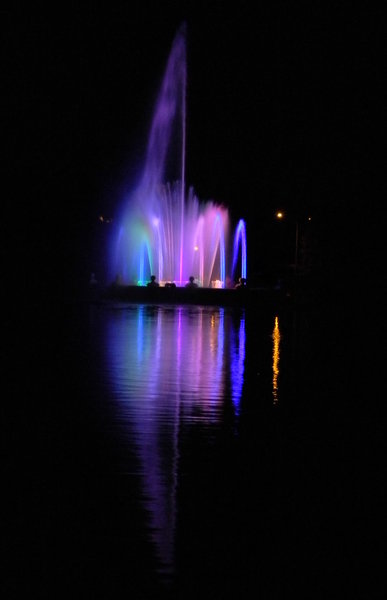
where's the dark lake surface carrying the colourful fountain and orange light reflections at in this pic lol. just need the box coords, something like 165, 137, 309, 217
8, 302, 384, 599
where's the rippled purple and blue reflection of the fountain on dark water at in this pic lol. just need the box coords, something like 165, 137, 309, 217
104, 305, 270, 576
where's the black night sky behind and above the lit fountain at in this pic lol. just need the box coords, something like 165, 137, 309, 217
3, 1, 382, 292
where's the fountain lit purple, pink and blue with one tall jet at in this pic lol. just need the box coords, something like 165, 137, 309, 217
111, 25, 246, 288
